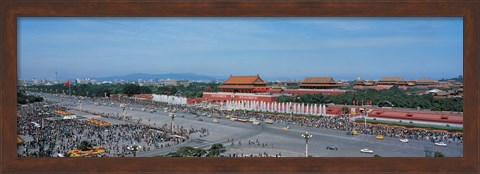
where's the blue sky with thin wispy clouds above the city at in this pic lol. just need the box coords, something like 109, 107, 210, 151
18, 17, 463, 80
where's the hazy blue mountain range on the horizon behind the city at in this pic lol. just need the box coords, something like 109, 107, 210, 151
92, 73, 224, 81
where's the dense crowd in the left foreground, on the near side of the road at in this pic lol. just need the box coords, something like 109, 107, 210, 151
17, 103, 208, 157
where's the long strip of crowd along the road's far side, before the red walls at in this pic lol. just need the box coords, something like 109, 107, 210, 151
168, 100, 463, 143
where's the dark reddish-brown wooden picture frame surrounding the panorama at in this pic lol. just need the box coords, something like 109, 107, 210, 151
0, 0, 480, 173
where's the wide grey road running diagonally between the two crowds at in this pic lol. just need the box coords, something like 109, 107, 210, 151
37, 94, 463, 157
